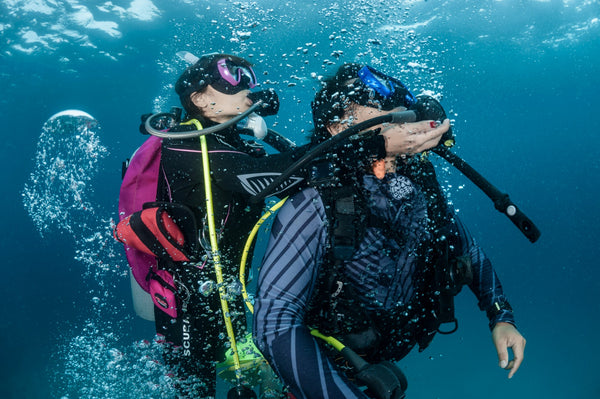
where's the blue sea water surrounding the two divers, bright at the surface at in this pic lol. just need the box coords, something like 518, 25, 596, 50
0, 0, 600, 399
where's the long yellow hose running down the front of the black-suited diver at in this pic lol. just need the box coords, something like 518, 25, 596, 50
185, 119, 242, 384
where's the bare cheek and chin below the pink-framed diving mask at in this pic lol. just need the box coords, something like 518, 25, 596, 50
192, 85, 252, 123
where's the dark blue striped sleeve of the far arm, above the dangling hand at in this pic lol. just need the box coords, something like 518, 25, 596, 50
454, 215, 515, 330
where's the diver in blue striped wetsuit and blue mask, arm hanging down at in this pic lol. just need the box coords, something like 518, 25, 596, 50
253, 63, 525, 399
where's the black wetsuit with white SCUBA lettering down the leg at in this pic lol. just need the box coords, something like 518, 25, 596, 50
155, 126, 307, 398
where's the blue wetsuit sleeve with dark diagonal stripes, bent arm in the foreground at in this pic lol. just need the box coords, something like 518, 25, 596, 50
254, 189, 366, 399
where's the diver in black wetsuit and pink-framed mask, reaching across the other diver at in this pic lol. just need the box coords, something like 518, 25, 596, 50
115, 54, 447, 398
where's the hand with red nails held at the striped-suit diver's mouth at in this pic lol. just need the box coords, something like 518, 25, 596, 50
381, 119, 450, 156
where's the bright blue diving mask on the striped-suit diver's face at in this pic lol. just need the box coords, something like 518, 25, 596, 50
358, 65, 416, 110
